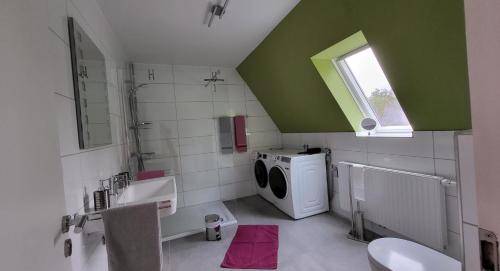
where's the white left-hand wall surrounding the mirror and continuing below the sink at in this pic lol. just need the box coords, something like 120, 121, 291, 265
46, 0, 127, 271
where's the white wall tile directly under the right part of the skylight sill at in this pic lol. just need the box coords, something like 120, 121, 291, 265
366, 132, 434, 157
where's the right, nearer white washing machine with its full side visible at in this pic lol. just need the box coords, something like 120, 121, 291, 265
267, 150, 329, 219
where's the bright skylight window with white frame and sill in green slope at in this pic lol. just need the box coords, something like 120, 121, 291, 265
334, 46, 413, 137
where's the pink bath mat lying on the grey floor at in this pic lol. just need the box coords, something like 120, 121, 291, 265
221, 225, 279, 269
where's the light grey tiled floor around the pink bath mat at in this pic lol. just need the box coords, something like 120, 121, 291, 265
163, 196, 369, 271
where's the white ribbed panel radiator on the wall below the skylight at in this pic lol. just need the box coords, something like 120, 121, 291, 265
339, 163, 447, 251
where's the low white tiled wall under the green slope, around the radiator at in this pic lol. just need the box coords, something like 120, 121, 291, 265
282, 131, 461, 259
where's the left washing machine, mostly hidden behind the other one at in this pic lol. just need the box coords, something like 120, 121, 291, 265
254, 152, 273, 201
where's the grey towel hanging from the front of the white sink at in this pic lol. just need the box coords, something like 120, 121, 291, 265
102, 202, 163, 271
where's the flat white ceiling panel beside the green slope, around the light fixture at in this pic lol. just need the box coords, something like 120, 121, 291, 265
98, 0, 300, 67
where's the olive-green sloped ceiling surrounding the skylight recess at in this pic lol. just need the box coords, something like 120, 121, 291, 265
237, 0, 471, 133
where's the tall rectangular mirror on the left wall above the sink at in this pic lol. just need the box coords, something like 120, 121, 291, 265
68, 17, 112, 149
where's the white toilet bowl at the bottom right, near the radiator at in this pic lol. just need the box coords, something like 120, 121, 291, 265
368, 238, 462, 271
